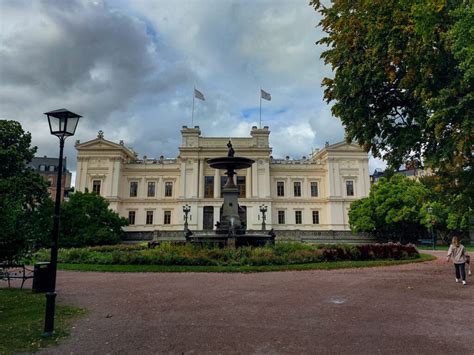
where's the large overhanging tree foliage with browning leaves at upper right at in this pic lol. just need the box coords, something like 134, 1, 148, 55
311, 0, 474, 221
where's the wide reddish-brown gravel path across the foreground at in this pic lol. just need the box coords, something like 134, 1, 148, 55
28, 252, 474, 354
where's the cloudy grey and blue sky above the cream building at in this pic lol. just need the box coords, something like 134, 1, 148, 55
0, 0, 382, 179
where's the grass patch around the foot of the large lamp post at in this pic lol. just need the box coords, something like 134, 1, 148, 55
0, 288, 85, 354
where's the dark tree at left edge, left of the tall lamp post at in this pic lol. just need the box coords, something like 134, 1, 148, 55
0, 120, 52, 262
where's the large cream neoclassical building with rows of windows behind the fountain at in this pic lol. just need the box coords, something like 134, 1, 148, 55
75, 126, 370, 241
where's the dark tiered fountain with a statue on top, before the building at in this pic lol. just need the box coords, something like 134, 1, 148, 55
185, 141, 275, 247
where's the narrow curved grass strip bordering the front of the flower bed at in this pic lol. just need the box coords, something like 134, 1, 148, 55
58, 254, 436, 272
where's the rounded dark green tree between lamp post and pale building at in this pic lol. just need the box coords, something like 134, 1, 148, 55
59, 192, 128, 247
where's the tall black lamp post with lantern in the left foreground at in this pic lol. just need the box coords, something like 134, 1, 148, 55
43, 108, 82, 336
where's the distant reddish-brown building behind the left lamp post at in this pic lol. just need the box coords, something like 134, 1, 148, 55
28, 156, 72, 201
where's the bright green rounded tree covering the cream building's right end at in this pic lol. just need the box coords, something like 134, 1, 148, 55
349, 175, 429, 243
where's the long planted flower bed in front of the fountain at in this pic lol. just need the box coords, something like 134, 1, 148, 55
36, 242, 419, 266
